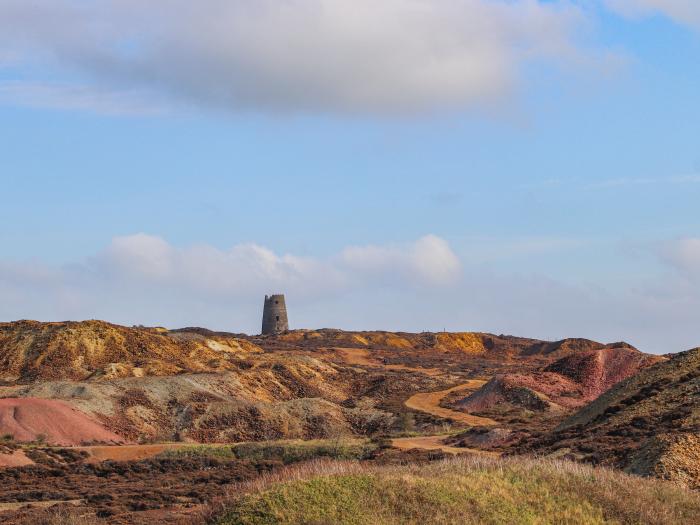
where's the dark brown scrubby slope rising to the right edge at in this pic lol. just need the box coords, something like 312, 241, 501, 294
521, 348, 700, 488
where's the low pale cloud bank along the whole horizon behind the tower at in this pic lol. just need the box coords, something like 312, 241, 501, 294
0, 234, 700, 353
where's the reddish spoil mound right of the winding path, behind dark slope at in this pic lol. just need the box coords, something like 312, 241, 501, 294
458, 348, 663, 412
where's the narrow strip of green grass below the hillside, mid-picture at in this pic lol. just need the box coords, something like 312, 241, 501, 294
160, 439, 377, 464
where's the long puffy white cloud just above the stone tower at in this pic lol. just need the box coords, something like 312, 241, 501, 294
91, 233, 460, 295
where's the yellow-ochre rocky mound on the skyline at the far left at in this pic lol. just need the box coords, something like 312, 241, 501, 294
0, 321, 261, 382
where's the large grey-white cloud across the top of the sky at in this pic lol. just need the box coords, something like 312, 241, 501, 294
0, 0, 584, 113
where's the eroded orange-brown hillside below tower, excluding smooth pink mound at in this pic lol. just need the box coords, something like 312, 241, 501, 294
0, 321, 658, 456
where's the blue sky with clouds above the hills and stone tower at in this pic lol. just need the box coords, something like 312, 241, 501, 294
0, 0, 700, 353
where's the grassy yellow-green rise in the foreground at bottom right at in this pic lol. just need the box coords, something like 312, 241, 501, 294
211, 457, 700, 525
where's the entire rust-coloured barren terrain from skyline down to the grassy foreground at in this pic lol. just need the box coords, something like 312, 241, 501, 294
0, 321, 698, 523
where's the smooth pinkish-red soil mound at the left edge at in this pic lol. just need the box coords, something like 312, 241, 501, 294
0, 398, 124, 446
